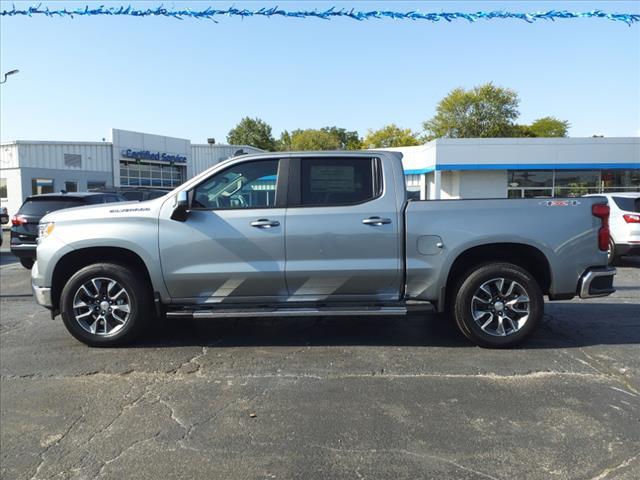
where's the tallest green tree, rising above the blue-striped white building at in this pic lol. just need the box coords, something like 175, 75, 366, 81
423, 83, 520, 139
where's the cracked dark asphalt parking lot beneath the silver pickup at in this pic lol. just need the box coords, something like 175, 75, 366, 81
0, 231, 640, 479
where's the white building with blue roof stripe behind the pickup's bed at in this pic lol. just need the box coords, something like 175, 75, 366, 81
385, 137, 640, 200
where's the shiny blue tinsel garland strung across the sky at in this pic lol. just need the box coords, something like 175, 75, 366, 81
0, 5, 640, 25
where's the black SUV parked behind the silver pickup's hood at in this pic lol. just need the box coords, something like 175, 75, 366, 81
11, 192, 127, 269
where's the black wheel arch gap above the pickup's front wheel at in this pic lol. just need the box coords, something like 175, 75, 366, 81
51, 247, 155, 312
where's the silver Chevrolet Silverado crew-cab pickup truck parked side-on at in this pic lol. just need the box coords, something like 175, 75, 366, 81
32, 151, 615, 347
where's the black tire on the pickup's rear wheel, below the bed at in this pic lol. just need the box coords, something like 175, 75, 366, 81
451, 262, 544, 348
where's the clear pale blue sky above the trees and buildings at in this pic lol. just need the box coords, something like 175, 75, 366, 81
0, 0, 640, 143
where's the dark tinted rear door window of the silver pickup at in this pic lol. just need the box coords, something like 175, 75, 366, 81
300, 157, 379, 206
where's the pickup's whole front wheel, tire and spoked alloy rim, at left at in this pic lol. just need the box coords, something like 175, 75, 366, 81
60, 263, 153, 347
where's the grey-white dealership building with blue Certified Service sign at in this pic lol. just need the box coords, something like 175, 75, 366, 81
0, 129, 262, 214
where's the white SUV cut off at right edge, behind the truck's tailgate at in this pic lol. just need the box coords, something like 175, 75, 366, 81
587, 192, 640, 265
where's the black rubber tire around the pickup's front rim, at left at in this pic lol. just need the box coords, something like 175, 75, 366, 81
60, 263, 153, 347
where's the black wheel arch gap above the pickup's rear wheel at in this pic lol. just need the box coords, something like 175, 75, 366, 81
438, 242, 553, 310
